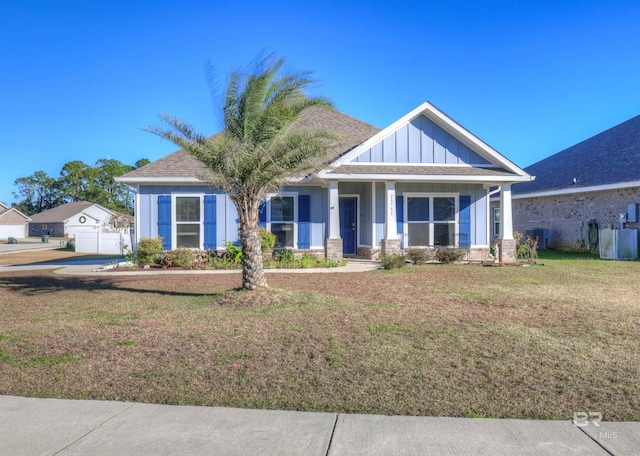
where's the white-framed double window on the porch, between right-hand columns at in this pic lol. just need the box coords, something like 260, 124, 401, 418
407, 196, 457, 247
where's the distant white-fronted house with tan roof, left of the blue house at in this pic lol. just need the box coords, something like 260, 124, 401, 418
29, 201, 117, 238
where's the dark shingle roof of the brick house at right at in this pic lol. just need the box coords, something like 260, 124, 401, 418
513, 116, 640, 194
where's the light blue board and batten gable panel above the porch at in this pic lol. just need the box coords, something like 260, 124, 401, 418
351, 115, 491, 166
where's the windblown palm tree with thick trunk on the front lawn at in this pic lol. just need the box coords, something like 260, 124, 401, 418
146, 54, 337, 289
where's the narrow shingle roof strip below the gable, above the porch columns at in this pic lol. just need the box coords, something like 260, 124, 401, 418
329, 165, 516, 177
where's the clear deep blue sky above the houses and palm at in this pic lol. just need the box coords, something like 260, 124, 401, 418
0, 0, 640, 203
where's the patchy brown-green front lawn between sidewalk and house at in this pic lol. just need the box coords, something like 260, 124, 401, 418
0, 255, 640, 421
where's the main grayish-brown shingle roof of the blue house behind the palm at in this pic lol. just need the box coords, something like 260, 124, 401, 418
122, 106, 380, 180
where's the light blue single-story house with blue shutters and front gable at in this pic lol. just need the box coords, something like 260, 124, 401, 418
116, 102, 532, 262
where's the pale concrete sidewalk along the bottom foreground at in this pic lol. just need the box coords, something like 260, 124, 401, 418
0, 396, 640, 456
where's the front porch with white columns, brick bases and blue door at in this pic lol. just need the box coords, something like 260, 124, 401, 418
324, 180, 516, 264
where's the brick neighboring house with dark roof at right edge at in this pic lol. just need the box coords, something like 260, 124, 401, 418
492, 116, 640, 248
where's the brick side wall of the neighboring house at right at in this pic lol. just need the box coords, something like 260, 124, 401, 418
491, 187, 640, 247
